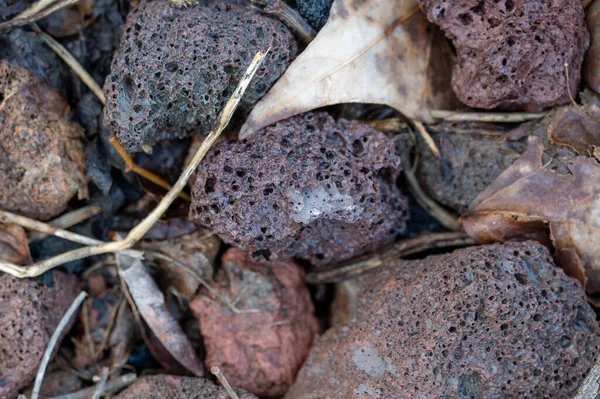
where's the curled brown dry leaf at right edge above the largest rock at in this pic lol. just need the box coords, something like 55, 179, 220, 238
461, 136, 600, 294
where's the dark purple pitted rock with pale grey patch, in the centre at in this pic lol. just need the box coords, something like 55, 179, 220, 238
190, 112, 408, 265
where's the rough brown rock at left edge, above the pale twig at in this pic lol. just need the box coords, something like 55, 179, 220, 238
0, 60, 87, 219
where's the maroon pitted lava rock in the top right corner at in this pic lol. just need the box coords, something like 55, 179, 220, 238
418, 0, 589, 111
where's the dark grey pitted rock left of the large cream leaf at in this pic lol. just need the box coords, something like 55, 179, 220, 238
104, 0, 297, 151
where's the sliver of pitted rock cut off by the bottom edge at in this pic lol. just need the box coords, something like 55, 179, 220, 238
117, 374, 256, 399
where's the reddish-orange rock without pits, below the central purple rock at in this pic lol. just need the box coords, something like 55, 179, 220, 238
190, 248, 319, 398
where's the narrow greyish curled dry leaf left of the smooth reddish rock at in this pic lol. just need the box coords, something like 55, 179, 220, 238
117, 254, 204, 377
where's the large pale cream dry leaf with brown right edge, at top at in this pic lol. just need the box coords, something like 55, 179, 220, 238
240, 0, 454, 138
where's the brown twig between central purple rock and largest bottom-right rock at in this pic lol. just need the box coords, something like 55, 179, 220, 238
306, 232, 474, 284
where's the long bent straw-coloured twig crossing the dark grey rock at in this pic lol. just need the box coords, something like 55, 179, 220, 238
0, 50, 268, 278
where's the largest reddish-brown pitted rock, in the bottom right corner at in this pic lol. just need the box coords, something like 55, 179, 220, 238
286, 242, 600, 399
